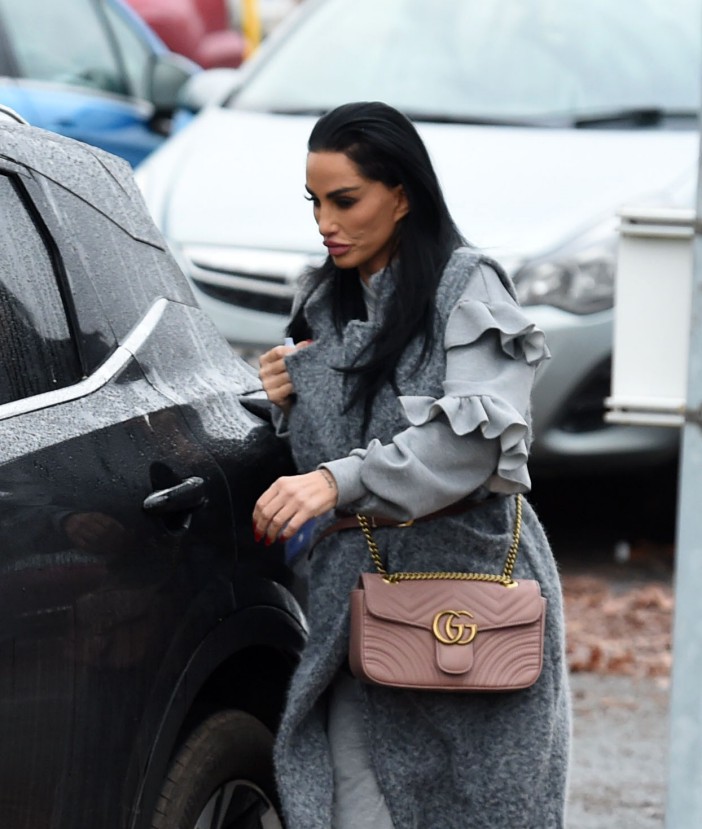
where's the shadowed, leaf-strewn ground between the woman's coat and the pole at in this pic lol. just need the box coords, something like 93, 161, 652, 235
534, 472, 674, 829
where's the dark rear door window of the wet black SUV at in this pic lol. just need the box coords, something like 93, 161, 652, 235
0, 174, 80, 404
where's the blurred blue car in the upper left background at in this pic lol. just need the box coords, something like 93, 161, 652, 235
0, 0, 199, 166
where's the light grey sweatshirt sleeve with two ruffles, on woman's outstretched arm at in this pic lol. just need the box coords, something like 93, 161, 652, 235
323, 267, 548, 520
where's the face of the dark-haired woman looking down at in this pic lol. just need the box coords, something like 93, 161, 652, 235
307, 152, 409, 281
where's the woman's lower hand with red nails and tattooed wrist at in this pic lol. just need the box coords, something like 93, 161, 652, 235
253, 469, 338, 545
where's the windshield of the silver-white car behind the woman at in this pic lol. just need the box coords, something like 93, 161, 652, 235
232, 0, 702, 126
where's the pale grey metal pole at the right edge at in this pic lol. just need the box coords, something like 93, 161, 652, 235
661, 129, 702, 829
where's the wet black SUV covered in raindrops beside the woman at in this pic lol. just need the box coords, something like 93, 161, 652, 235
0, 111, 305, 829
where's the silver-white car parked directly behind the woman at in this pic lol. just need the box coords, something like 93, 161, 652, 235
137, 0, 702, 471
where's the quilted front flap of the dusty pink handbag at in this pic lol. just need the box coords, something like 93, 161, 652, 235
360, 573, 544, 631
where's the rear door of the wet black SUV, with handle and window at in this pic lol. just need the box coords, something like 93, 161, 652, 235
0, 161, 235, 829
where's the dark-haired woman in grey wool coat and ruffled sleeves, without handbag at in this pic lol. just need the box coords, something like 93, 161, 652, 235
253, 103, 570, 829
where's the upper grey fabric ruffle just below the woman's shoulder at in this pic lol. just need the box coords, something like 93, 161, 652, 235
444, 299, 551, 366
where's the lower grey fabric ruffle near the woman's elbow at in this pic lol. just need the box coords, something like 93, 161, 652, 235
400, 395, 531, 492
